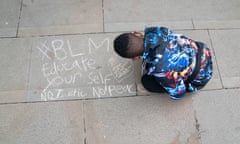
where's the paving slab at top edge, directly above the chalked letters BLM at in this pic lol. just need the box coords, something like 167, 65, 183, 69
18, 0, 103, 36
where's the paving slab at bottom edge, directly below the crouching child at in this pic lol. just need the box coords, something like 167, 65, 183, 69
84, 95, 199, 144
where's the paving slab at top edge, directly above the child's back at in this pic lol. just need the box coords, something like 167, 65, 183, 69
104, 0, 193, 32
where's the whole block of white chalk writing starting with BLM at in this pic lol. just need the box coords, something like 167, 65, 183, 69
36, 38, 136, 101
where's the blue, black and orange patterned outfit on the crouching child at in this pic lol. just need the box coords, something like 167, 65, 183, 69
143, 27, 212, 99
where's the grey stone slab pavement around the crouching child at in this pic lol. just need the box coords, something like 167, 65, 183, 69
0, 0, 240, 144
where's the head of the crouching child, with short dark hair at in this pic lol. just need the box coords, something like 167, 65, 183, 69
114, 32, 144, 59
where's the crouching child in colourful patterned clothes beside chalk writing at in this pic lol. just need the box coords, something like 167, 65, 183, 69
114, 27, 212, 99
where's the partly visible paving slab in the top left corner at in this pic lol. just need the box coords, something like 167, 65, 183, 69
0, 0, 21, 37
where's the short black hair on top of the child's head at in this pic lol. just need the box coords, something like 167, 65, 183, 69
113, 33, 130, 58
